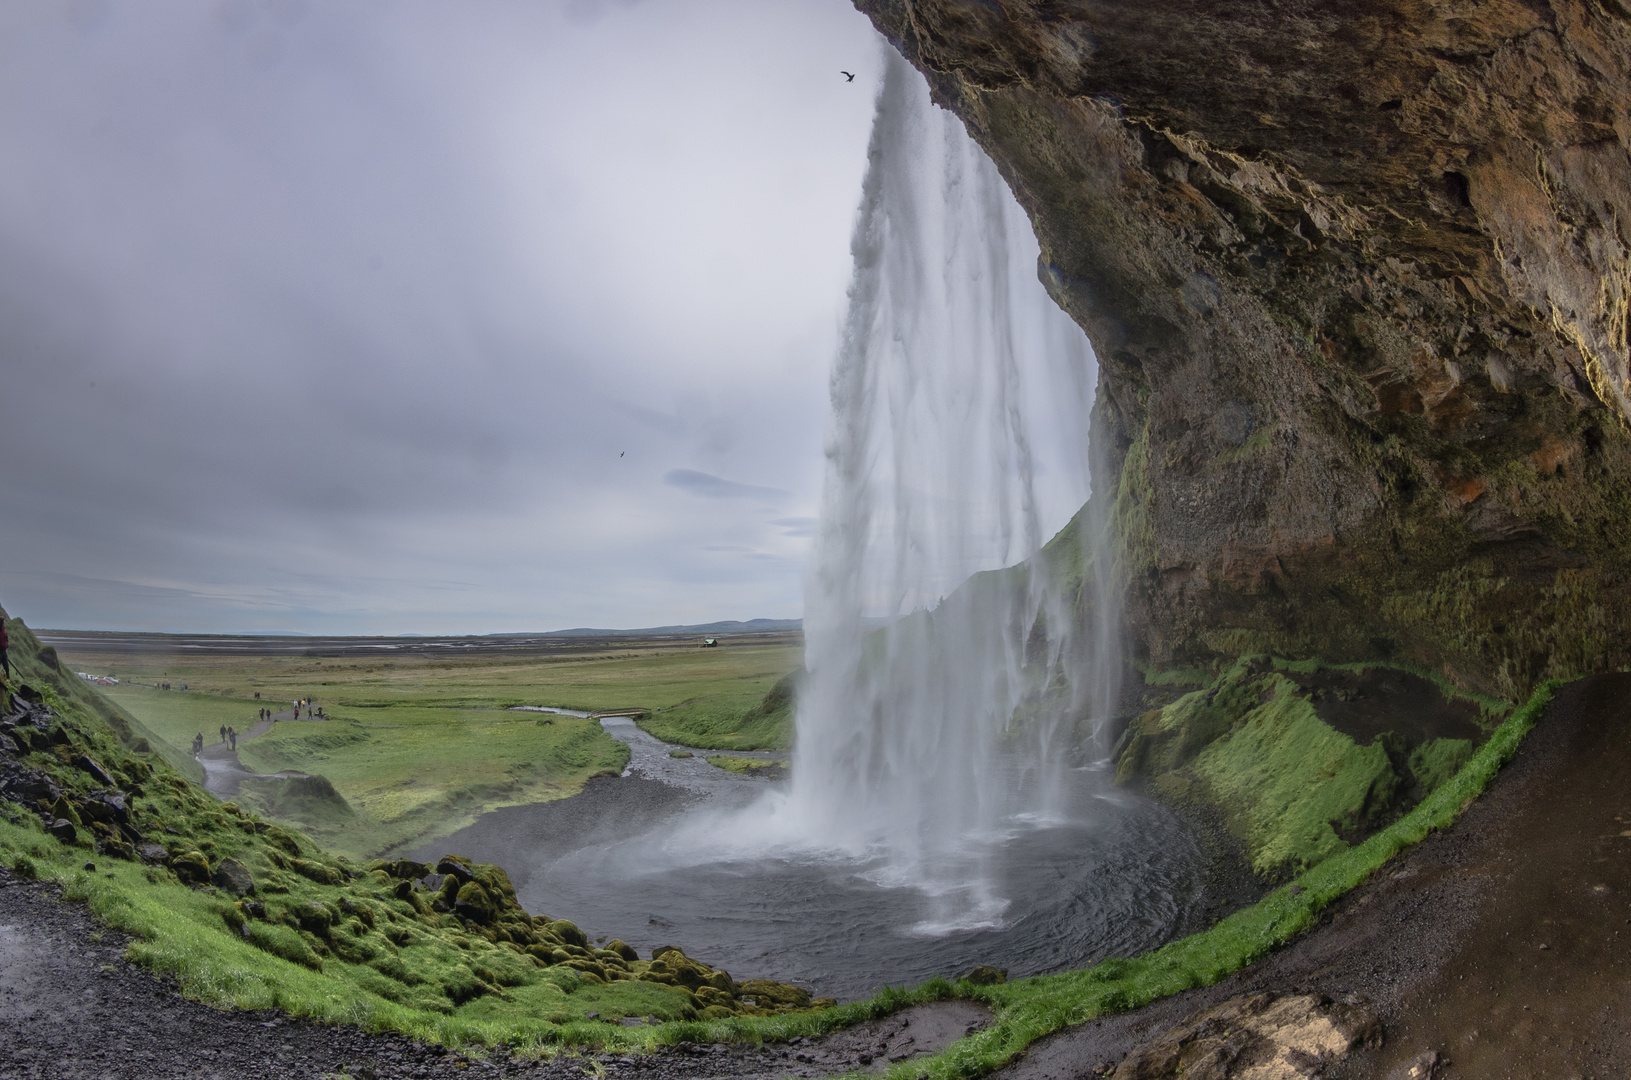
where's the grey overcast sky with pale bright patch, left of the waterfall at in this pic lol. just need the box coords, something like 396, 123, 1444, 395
0, 0, 900, 633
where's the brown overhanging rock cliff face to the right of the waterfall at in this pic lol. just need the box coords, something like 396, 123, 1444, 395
856, 0, 1631, 695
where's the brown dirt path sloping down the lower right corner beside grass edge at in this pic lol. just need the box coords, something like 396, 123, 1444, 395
1000, 675, 1631, 1080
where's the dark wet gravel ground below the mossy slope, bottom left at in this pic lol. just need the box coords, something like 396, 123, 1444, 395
0, 868, 987, 1080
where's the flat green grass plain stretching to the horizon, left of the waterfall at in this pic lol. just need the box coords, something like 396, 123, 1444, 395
59, 640, 802, 858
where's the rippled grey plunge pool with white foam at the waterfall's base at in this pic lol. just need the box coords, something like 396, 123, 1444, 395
511, 719, 1204, 998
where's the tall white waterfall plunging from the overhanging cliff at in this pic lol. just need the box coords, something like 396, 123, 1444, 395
778, 49, 1119, 930
